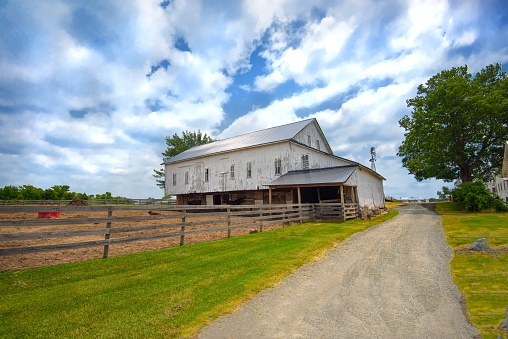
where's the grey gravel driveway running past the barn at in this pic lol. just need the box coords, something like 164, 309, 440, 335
199, 205, 478, 338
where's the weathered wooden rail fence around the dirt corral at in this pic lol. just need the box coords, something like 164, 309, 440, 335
0, 204, 358, 258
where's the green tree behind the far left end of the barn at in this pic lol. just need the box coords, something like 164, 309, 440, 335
153, 130, 214, 189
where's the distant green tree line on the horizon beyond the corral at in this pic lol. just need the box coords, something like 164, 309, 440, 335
0, 185, 126, 200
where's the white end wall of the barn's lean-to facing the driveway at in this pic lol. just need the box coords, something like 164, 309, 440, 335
346, 167, 385, 209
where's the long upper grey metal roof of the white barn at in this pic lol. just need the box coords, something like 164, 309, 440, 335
164, 119, 316, 164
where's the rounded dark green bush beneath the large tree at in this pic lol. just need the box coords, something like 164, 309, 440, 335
452, 181, 495, 211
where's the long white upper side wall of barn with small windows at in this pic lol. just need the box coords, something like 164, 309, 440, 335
165, 142, 350, 195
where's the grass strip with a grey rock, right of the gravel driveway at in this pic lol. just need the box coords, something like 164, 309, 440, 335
436, 203, 508, 339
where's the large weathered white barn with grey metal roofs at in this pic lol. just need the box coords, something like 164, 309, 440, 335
164, 119, 385, 209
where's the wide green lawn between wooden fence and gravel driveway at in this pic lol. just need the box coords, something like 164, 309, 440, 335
0, 211, 398, 338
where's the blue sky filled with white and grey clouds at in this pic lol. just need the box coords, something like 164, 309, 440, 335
0, 0, 508, 198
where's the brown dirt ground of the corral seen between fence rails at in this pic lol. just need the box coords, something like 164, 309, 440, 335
0, 210, 282, 272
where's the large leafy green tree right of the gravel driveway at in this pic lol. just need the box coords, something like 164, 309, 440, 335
398, 65, 508, 182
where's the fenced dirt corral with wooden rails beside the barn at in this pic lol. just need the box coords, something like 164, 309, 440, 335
0, 204, 358, 271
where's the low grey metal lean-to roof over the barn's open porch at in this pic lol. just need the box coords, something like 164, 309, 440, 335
267, 165, 358, 186
